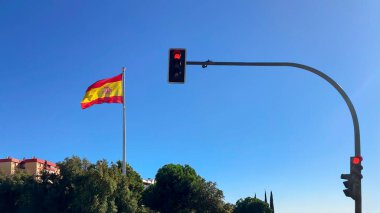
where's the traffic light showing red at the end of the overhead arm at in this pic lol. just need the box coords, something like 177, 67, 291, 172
169, 48, 186, 83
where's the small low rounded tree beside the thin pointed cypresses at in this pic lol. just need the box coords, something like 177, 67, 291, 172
234, 197, 273, 213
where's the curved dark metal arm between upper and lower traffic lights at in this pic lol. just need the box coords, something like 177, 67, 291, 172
186, 61, 361, 156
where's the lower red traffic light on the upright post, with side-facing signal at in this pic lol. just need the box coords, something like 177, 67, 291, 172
340, 156, 363, 200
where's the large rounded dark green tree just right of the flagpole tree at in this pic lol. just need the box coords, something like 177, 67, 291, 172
142, 164, 226, 213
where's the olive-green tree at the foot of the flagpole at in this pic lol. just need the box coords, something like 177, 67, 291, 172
58, 156, 143, 212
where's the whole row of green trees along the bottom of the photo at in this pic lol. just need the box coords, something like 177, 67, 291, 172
0, 157, 272, 213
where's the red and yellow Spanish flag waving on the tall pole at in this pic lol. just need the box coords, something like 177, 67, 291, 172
81, 74, 123, 109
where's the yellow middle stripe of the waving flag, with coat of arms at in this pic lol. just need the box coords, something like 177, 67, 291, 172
82, 81, 123, 103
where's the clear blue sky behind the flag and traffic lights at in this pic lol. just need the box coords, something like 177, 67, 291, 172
0, 0, 380, 213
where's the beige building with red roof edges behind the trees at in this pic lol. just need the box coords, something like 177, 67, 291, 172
0, 157, 59, 175
